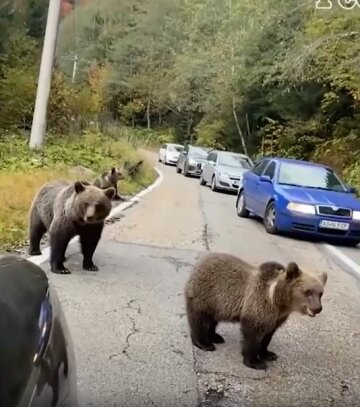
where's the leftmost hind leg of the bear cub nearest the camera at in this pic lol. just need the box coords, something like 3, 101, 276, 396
186, 299, 216, 352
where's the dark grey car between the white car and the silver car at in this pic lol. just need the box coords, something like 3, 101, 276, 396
176, 144, 210, 177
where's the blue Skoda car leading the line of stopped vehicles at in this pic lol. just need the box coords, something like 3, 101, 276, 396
236, 157, 360, 245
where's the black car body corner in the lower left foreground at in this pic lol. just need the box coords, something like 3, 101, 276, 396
0, 255, 78, 407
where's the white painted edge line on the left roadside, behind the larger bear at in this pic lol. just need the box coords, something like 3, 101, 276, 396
26, 167, 164, 266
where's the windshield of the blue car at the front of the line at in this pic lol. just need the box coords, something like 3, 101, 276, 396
278, 163, 346, 192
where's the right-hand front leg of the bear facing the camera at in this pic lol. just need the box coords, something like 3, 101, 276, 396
79, 223, 104, 271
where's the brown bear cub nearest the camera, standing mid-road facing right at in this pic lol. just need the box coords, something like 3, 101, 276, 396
185, 253, 327, 369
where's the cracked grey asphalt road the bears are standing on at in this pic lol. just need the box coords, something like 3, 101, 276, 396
38, 154, 360, 407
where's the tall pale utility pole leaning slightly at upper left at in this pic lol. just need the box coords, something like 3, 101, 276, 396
29, 0, 61, 148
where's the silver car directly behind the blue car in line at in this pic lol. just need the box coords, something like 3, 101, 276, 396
200, 150, 253, 192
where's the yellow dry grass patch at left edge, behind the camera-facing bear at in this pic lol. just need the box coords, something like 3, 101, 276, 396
0, 169, 74, 251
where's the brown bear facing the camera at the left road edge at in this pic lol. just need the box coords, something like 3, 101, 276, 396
29, 181, 115, 274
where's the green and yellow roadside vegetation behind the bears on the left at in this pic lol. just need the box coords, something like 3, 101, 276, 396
0, 132, 156, 251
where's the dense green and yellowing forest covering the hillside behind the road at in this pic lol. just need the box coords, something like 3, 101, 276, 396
0, 0, 360, 249
